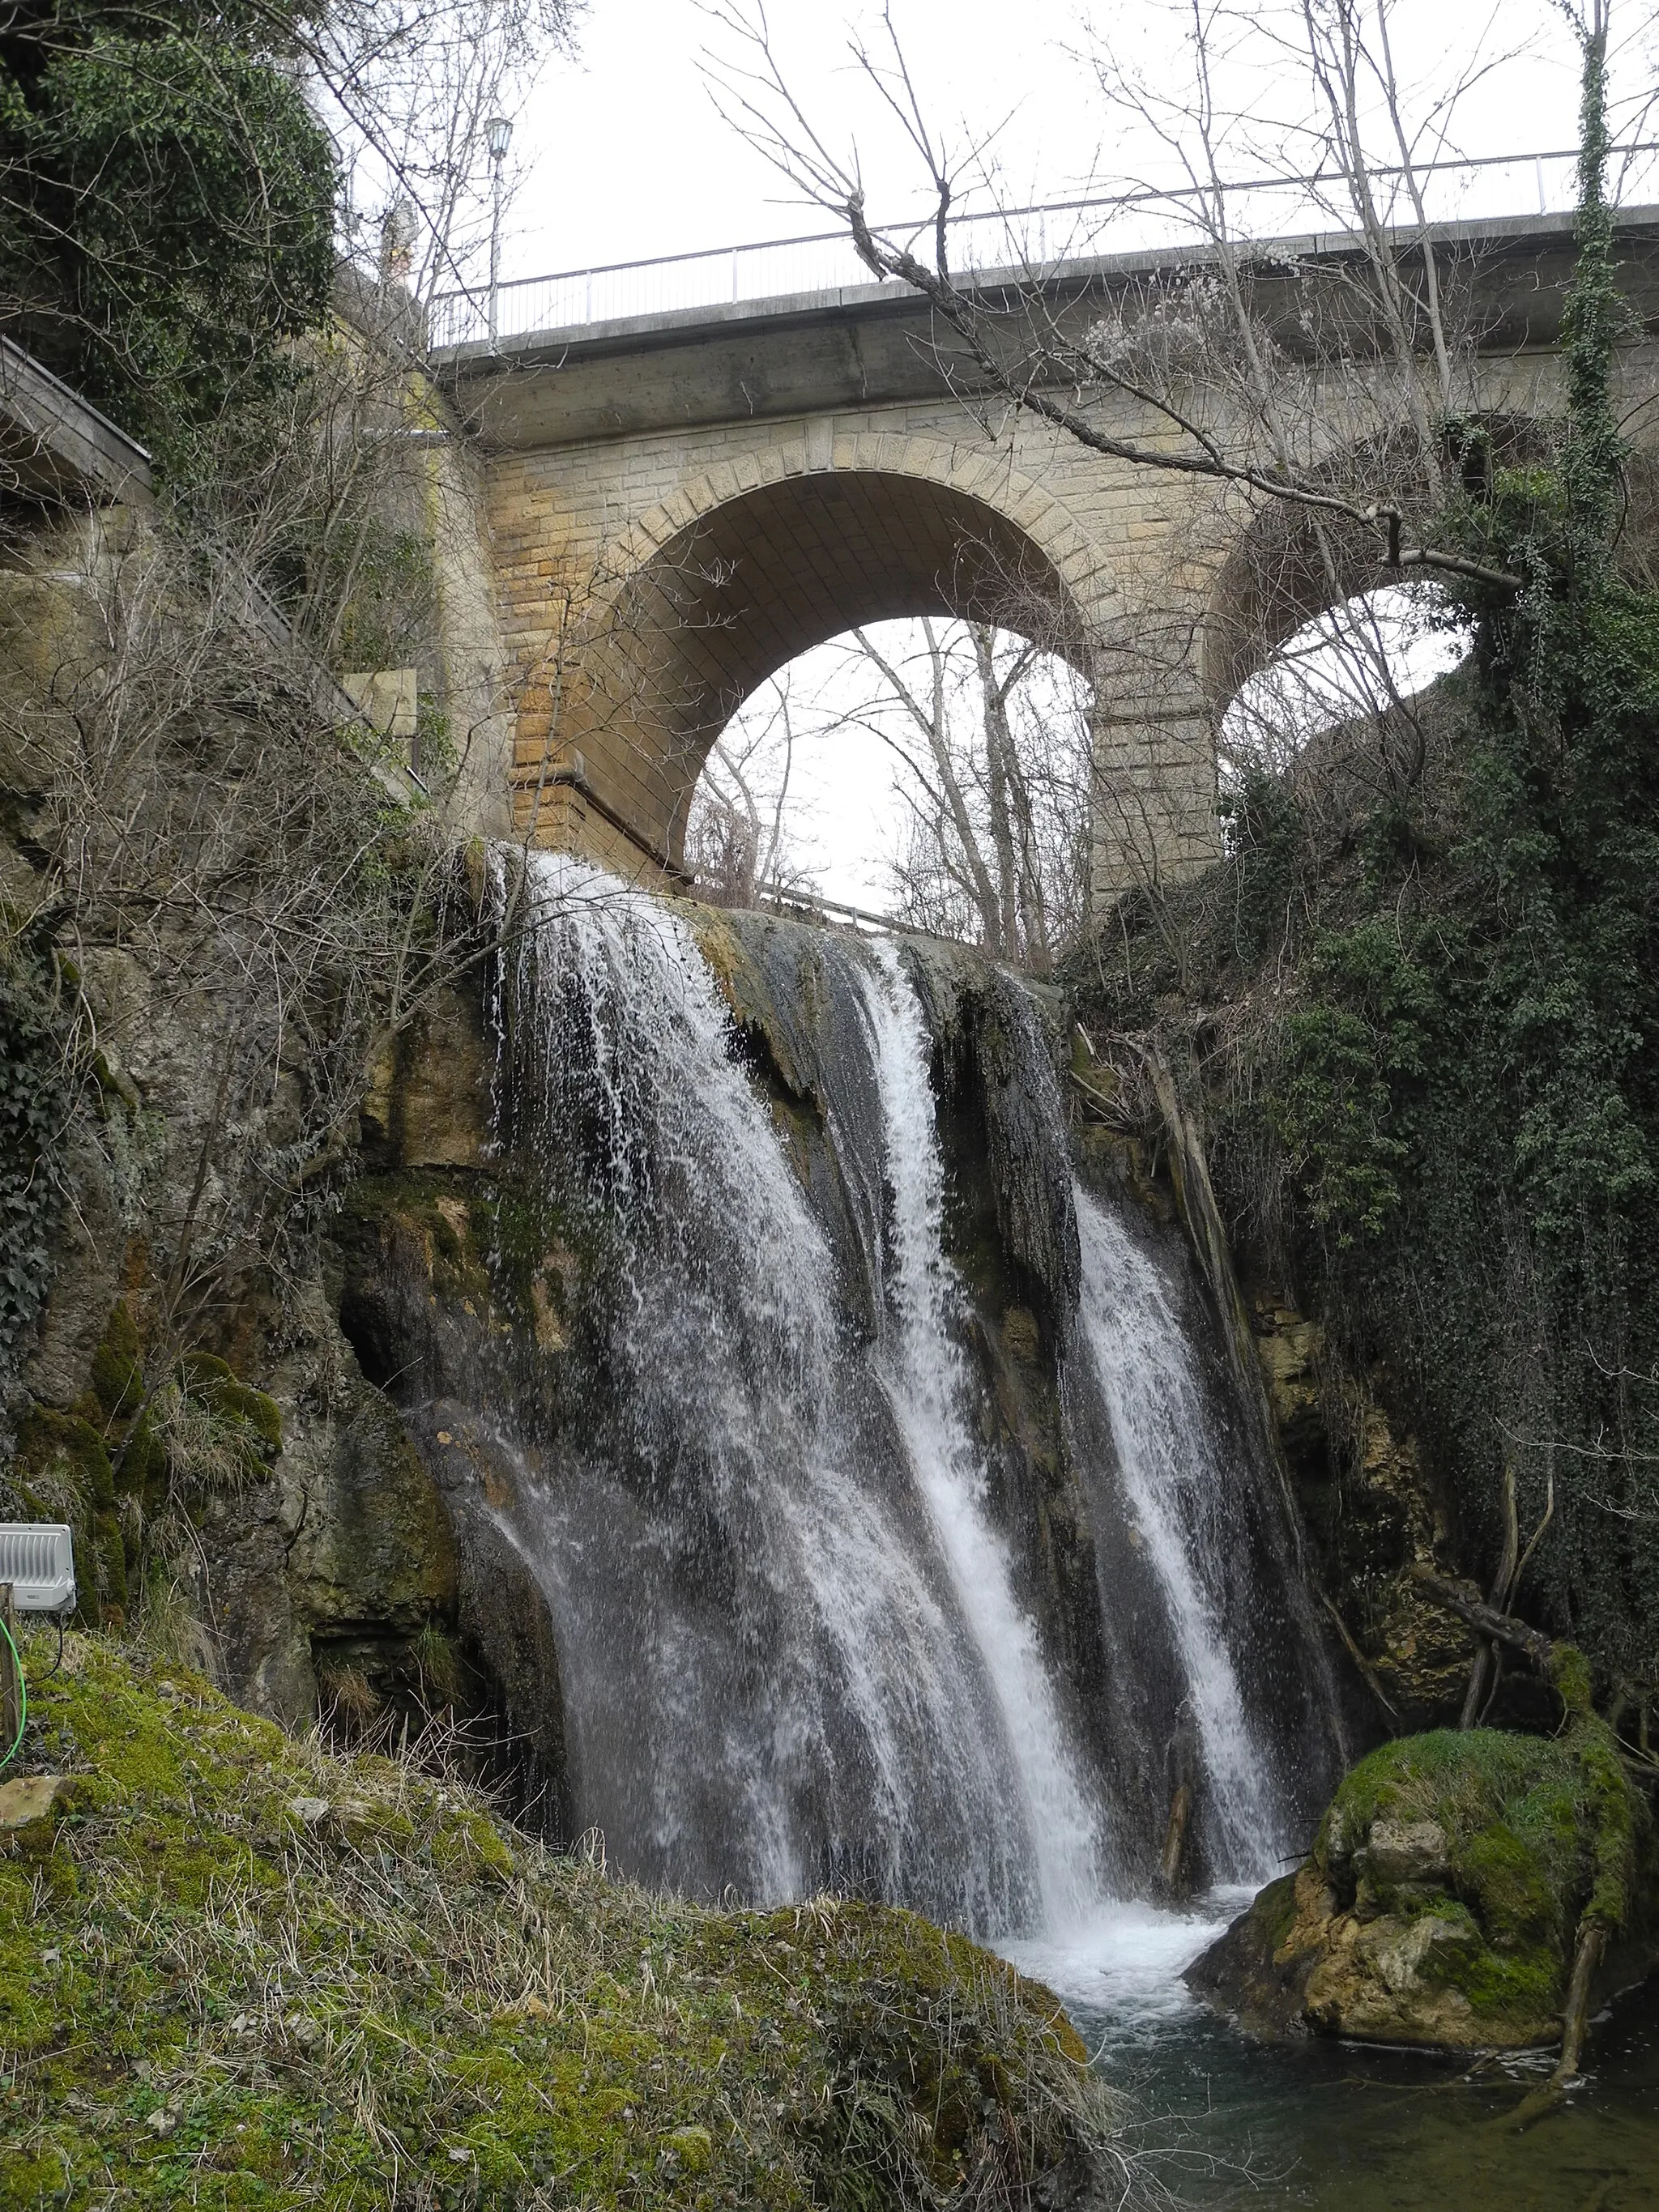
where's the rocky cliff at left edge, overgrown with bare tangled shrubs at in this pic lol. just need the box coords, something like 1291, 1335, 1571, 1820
0, 509, 480, 1719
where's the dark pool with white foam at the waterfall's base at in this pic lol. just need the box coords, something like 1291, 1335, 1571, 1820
1009, 1891, 1659, 2212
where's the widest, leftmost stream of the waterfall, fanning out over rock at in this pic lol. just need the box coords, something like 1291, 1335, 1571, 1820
486, 856, 1042, 1931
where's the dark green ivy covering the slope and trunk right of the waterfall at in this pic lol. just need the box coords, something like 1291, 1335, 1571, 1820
1075, 26, 1659, 1730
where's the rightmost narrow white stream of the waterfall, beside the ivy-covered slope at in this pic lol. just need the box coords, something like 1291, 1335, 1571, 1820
1073, 1186, 1286, 1882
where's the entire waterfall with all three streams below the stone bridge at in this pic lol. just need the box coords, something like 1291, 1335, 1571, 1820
471, 854, 1336, 1937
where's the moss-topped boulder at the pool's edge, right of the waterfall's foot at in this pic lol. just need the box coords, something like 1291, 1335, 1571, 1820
1188, 1721, 1659, 2051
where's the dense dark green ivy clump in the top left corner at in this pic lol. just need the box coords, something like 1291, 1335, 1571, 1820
0, 0, 336, 456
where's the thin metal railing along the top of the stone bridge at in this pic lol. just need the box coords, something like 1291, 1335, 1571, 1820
429, 139, 1659, 352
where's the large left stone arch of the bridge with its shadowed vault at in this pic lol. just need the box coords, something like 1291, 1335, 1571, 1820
518, 433, 1111, 867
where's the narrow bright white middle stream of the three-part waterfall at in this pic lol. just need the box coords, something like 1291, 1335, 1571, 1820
863, 940, 1102, 1927
